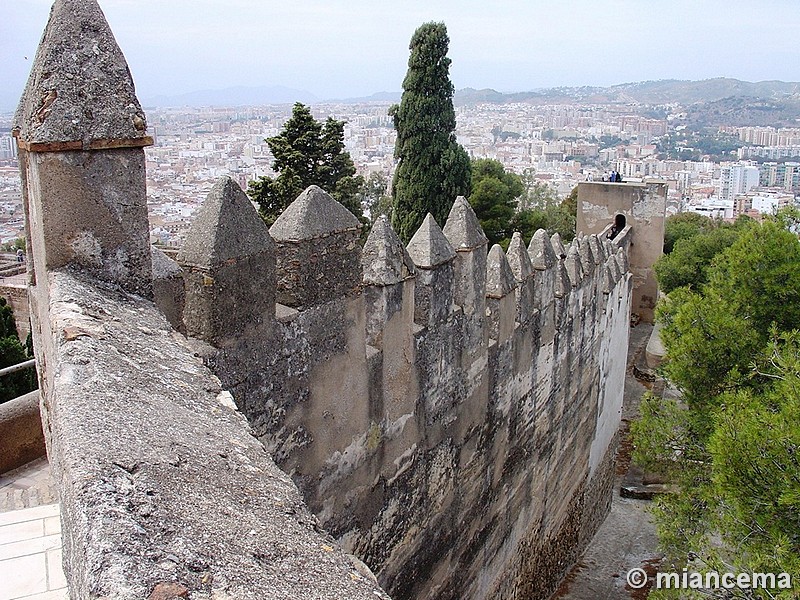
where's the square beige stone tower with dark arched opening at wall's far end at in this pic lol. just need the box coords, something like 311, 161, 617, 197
576, 181, 667, 323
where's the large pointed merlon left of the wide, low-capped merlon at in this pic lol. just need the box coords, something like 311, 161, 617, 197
178, 177, 276, 346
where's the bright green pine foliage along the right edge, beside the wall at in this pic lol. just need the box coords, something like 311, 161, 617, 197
632, 219, 800, 598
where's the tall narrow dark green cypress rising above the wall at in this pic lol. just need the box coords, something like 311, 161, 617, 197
389, 23, 470, 241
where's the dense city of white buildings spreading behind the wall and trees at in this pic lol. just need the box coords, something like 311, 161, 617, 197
0, 102, 800, 246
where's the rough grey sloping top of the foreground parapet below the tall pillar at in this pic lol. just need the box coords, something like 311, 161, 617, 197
36, 272, 387, 600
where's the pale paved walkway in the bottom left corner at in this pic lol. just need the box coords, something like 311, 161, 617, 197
0, 458, 69, 600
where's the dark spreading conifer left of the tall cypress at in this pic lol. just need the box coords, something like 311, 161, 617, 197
247, 102, 364, 225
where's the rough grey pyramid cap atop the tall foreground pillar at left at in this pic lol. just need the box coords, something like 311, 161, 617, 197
13, 0, 153, 152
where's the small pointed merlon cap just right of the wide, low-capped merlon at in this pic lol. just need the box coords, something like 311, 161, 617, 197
361, 215, 415, 285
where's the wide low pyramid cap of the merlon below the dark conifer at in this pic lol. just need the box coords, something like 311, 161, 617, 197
269, 185, 361, 242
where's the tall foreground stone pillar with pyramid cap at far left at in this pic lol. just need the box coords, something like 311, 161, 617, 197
14, 0, 153, 297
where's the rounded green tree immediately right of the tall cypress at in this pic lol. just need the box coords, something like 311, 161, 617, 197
469, 158, 525, 246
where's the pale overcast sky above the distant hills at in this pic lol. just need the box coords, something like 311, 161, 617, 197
0, 0, 800, 110
